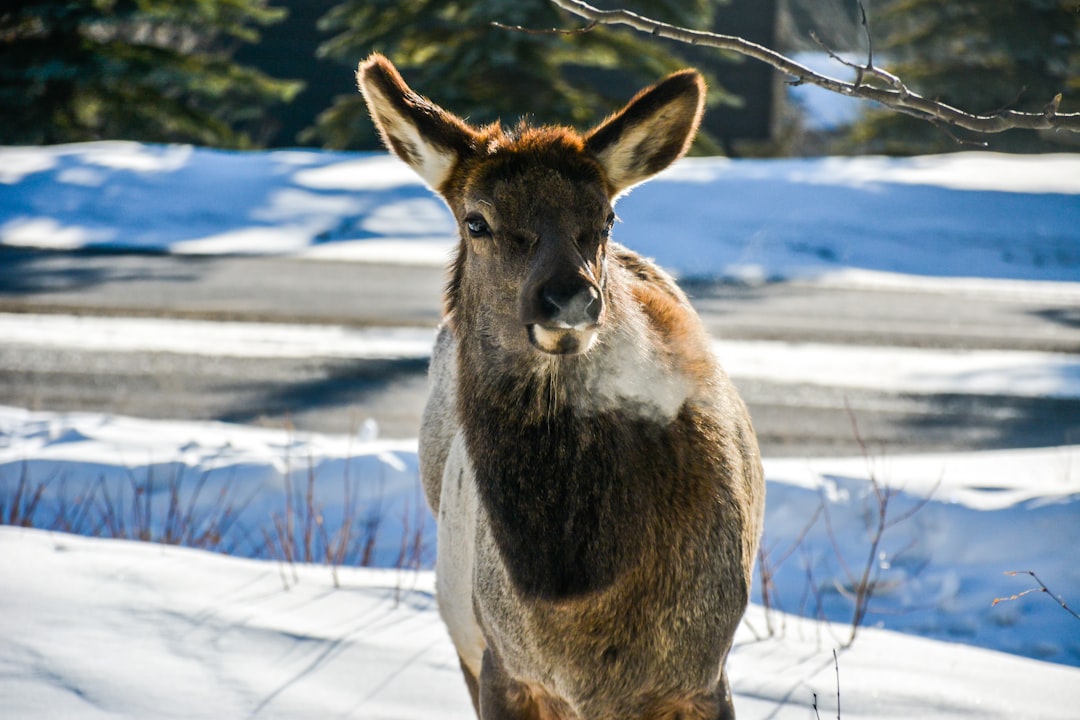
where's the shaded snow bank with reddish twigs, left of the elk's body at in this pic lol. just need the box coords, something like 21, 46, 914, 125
0, 407, 435, 567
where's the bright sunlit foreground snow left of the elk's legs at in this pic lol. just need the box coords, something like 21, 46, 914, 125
0, 528, 460, 720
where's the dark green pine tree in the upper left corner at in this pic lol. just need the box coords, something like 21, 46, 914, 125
0, 0, 299, 147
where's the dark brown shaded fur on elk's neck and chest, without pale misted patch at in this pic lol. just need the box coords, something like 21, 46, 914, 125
458, 338, 680, 599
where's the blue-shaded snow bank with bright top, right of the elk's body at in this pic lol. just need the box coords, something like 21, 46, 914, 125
755, 447, 1080, 666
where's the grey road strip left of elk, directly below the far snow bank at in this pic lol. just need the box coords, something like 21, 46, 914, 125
0, 247, 443, 326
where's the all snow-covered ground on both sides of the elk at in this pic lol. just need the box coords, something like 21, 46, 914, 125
0, 142, 1080, 719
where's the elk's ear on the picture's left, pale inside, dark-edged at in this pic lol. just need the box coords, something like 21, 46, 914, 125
356, 53, 476, 190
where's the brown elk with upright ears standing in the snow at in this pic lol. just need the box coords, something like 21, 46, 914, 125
357, 54, 765, 720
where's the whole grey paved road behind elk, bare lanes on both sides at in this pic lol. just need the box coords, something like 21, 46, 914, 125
6, 249, 1080, 456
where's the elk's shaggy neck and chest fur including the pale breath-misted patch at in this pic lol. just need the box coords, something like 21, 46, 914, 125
456, 254, 700, 600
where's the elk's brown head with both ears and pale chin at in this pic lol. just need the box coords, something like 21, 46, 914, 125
356, 55, 704, 355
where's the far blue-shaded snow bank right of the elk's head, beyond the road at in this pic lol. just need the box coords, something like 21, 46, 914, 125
630, 153, 1080, 282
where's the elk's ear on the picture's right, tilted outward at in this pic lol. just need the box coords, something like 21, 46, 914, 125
585, 70, 705, 195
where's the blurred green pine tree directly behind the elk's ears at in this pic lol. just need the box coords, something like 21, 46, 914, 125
308, 0, 730, 148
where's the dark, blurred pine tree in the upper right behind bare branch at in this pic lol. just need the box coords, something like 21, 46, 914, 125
852, 0, 1080, 154
